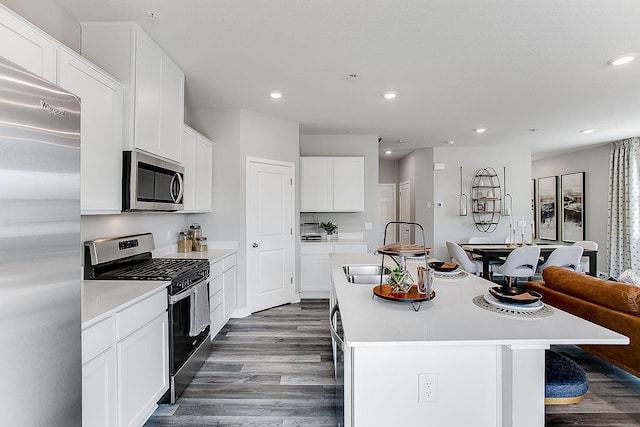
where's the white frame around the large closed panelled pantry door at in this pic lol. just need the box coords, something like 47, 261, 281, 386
244, 156, 298, 313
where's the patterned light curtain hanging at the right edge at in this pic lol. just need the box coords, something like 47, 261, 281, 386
607, 137, 640, 277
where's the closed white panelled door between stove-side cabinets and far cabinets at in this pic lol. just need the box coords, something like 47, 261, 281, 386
246, 158, 295, 312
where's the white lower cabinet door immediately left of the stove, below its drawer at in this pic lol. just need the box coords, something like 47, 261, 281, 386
117, 312, 169, 426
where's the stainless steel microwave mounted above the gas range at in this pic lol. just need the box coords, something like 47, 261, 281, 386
122, 151, 184, 212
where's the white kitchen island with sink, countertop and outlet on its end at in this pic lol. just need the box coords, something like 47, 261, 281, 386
331, 254, 629, 427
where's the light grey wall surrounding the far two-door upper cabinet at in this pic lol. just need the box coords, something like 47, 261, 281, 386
298, 135, 380, 251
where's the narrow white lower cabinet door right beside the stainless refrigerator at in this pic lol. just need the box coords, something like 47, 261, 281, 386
82, 347, 117, 427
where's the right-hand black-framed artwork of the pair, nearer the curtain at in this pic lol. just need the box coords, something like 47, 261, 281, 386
560, 172, 584, 242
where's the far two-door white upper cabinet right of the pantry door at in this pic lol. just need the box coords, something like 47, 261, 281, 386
300, 157, 364, 212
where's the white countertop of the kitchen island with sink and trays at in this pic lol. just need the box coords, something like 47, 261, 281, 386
331, 254, 629, 346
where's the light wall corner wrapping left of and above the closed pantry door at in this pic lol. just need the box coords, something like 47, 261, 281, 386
190, 108, 300, 309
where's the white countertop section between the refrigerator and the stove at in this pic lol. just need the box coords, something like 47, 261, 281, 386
81, 280, 171, 328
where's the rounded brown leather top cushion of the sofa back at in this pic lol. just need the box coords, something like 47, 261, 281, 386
542, 267, 640, 316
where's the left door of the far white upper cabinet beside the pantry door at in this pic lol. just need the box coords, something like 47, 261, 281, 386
300, 157, 333, 212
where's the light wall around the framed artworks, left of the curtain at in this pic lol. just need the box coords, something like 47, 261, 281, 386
531, 144, 611, 272
